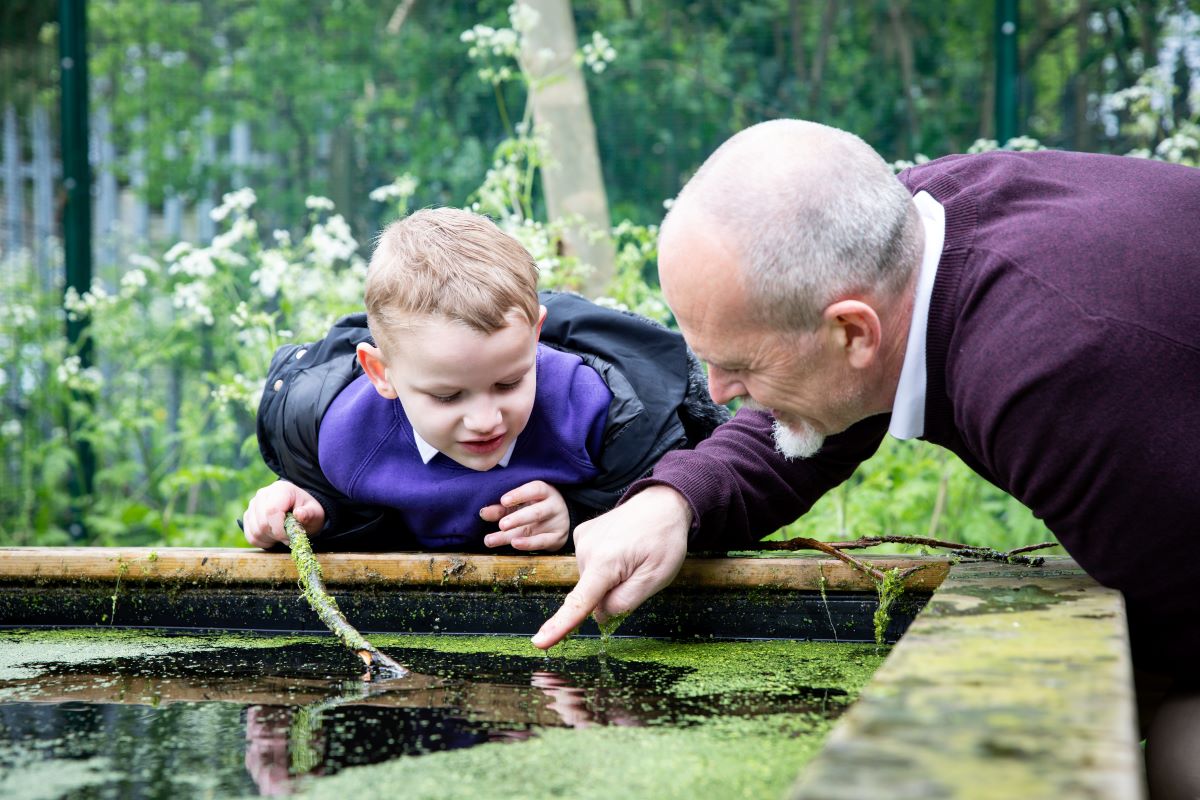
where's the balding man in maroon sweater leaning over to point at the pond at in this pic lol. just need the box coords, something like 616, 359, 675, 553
534, 120, 1200, 796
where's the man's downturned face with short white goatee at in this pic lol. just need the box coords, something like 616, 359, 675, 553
659, 208, 866, 458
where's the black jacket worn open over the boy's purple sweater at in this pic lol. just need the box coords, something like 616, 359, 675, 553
258, 291, 728, 549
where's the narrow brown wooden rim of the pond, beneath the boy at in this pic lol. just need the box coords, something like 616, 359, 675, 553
0, 547, 949, 593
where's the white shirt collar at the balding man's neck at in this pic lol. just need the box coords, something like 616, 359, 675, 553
888, 192, 946, 439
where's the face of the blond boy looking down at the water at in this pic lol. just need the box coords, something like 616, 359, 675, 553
359, 308, 546, 471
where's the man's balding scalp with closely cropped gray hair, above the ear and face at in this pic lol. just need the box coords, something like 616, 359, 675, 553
662, 120, 922, 331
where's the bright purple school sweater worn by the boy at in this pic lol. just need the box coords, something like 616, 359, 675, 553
317, 344, 612, 549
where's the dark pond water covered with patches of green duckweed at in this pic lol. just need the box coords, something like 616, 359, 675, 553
0, 628, 884, 800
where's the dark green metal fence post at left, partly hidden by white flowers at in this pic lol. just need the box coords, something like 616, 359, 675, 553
59, 0, 96, 539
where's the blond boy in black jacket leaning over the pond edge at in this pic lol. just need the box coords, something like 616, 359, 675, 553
241, 209, 727, 551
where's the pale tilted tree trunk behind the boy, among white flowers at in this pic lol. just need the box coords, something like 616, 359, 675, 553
522, 0, 616, 297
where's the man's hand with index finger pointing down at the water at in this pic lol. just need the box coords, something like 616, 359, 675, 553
533, 486, 691, 650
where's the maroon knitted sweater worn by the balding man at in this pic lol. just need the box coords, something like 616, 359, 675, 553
630, 151, 1200, 667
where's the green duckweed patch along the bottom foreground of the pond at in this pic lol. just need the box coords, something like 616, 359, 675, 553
298, 715, 832, 800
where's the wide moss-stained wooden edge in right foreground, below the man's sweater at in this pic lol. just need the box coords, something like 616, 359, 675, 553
791, 559, 1144, 800
